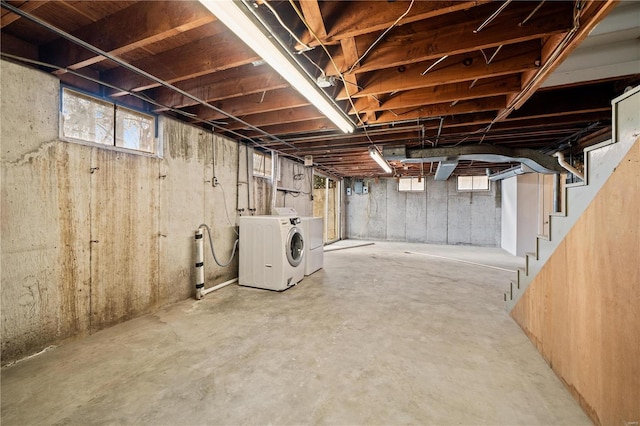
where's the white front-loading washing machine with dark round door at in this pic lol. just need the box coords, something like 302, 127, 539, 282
238, 216, 305, 291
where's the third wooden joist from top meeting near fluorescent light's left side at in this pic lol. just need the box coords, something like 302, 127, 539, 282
149, 65, 289, 111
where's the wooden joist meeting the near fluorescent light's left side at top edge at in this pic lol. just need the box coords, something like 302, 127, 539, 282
41, 1, 219, 69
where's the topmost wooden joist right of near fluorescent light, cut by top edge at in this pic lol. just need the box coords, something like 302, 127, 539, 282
302, 0, 487, 45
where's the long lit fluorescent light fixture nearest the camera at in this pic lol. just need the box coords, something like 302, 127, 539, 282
200, 0, 353, 133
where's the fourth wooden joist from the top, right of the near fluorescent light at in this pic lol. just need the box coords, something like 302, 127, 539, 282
349, 75, 520, 114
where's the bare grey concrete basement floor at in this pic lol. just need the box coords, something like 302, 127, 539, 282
1, 243, 590, 425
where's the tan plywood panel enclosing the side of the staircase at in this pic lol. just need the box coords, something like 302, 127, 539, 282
512, 139, 640, 425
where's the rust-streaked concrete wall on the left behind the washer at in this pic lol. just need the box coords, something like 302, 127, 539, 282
0, 61, 311, 364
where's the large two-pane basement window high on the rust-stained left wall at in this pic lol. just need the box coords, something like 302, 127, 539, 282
60, 87, 157, 154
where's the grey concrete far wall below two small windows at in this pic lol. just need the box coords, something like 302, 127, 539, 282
345, 177, 501, 247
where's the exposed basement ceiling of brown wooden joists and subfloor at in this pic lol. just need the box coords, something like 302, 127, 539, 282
1, 0, 640, 177
